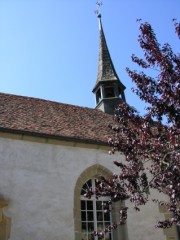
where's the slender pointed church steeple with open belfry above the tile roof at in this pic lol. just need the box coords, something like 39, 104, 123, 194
93, 8, 125, 114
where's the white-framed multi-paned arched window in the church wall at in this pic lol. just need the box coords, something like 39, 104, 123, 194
81, 179, 113, 240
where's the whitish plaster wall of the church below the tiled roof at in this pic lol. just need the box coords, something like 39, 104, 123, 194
0, 138, 164, 240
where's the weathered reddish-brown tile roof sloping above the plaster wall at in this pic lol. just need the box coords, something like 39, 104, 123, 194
0, 93, 113, 144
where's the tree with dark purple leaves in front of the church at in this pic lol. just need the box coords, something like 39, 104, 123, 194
87, 20, 180, 236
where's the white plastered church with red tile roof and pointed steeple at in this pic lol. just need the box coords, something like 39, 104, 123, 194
0, 9, 178, 240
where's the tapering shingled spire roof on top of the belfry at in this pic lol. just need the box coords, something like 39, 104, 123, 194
94, 14, 125, 89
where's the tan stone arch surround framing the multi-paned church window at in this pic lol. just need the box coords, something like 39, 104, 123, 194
74, 164, 127, 240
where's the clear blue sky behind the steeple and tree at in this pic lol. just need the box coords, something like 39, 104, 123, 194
0, 0, 180, 115
